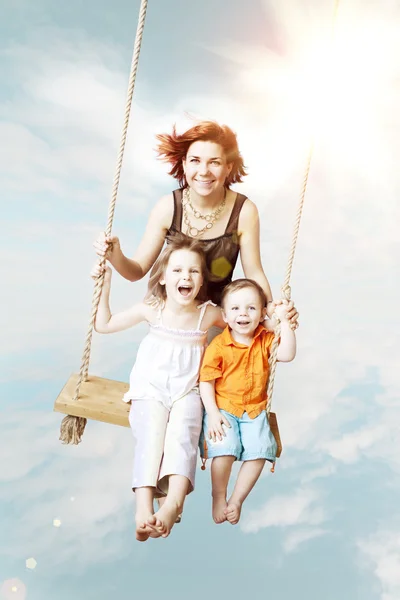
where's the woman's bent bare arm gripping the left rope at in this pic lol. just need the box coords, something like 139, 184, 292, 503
94, 194, 174, 281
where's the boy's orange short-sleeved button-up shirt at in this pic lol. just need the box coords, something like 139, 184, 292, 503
200, 325, 274, 419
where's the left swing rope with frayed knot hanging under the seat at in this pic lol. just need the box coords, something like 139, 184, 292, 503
60, 0, 148, 444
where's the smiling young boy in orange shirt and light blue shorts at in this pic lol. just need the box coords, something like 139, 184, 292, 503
200, 279, 296, 525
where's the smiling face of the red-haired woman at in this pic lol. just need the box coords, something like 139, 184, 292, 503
183, 141, 232, 196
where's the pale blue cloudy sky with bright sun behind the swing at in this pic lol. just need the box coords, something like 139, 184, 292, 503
0, 0, 400, 600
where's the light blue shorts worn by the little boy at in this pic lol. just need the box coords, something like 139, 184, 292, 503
200, 409, 277, 462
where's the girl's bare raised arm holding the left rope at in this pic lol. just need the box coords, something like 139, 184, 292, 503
94, 267, 152, 333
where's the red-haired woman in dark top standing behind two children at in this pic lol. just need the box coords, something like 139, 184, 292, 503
94, 121, 298, 329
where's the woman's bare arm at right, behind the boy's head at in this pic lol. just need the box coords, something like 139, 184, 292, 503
238, 199, 272, 302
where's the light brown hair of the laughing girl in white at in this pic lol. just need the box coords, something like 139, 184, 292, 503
144, 233, 208, 306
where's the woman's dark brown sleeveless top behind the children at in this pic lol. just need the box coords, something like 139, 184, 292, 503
166, 189, 247, 304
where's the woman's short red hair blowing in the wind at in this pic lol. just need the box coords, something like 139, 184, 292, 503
156, 121, 247, 187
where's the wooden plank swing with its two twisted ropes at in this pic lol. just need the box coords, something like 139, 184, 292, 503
54, 0, 324, 448
